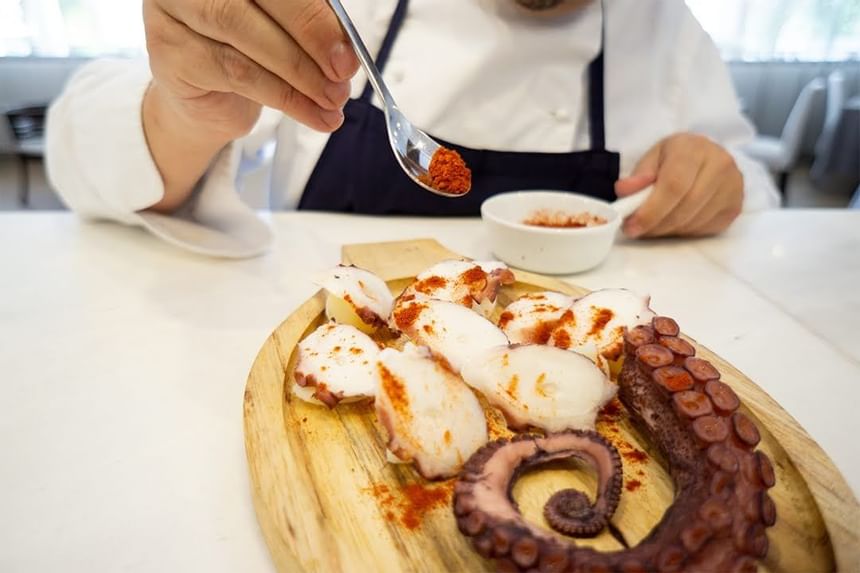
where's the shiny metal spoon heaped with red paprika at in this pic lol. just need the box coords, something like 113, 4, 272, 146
328, 0, 463, 197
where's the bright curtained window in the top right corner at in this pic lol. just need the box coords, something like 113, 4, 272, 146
687, 0, 860, 61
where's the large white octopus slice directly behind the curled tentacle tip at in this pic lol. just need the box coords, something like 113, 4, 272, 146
462, 345, 616, 432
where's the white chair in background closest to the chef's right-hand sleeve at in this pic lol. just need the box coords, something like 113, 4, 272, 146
744, 78, 824, 195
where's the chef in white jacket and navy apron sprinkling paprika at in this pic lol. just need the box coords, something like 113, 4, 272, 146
47, 0, 778, 256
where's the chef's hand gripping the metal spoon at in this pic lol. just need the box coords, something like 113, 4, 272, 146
143, 0, 358, 137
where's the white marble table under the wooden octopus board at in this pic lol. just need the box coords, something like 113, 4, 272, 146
0, 211, 860, 573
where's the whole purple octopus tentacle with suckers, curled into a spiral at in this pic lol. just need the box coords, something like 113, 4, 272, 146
454, 317, 777, 572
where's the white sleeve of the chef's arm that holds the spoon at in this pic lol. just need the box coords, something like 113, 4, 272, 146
45, 60, 278, 257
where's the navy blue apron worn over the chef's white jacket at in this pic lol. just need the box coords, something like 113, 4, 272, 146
299, 0, 620, 216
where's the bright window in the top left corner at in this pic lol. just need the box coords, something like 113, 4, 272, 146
0, 0, 145, 56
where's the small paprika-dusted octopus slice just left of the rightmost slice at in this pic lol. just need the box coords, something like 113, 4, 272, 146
499, 291, 576, 344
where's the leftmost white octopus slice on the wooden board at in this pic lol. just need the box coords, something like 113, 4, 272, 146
293, 322, 379, 408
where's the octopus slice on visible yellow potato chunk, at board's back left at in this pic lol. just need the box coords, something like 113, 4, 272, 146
317, 265, 394, 333
